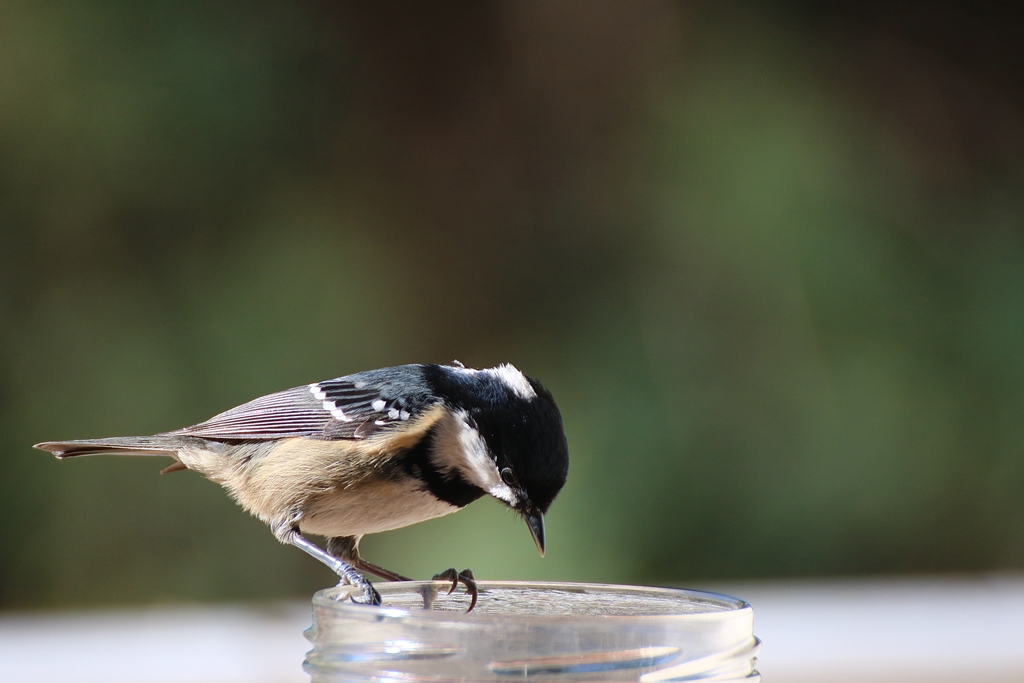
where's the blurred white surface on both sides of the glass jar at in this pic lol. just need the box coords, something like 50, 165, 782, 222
0, 577, 1024, 683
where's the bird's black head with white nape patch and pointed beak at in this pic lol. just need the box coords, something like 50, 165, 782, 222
424, 365, 569, 553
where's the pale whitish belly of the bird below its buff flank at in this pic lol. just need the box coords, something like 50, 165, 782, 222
299, 482, 459, 537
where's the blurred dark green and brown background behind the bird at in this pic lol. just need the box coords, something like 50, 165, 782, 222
0, 0, 1024, 608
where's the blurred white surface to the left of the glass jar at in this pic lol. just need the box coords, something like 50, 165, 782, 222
0, 603, 311, 683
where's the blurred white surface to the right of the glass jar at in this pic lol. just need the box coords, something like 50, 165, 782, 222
719, 575, 1024, 683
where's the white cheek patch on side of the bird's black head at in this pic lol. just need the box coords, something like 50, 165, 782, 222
433, 411, 518, 505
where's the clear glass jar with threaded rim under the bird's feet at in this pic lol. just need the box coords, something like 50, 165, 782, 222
304, 582, 761, 683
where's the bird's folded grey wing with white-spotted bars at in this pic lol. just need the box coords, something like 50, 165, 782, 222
171, 371, 433, 440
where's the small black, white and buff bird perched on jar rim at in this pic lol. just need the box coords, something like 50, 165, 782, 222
35, 361, 568, 609
